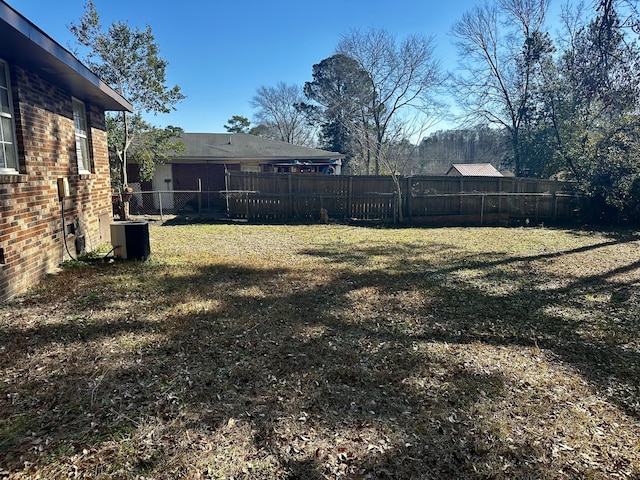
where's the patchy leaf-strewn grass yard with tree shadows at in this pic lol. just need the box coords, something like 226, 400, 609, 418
0, 225, 640, 480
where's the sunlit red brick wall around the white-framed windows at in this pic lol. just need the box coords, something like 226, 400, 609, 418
0, 65, 111, 301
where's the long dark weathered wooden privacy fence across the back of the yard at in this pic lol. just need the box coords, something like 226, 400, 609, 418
223, 172, 585, 224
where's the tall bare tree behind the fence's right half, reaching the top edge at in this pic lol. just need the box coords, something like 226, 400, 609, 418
452, 0, 552, 174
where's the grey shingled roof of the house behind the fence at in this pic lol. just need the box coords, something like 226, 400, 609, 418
172, 133, 344, 162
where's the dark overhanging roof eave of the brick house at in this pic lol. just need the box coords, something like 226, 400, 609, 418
0, 1, 133, 112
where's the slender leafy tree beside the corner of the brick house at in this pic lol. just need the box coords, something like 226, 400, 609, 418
69, 0, 184, 189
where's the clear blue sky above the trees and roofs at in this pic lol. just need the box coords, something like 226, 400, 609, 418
7, 0, 524, 132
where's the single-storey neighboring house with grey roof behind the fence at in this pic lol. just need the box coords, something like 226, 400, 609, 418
127, 133, 345, 208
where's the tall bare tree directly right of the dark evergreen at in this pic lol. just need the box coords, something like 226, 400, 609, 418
336, 29, 441, 175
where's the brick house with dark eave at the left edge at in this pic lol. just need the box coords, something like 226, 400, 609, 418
0, 2, 132, 301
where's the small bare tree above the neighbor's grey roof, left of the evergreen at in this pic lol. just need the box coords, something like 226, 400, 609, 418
251, 82, 315, 146
